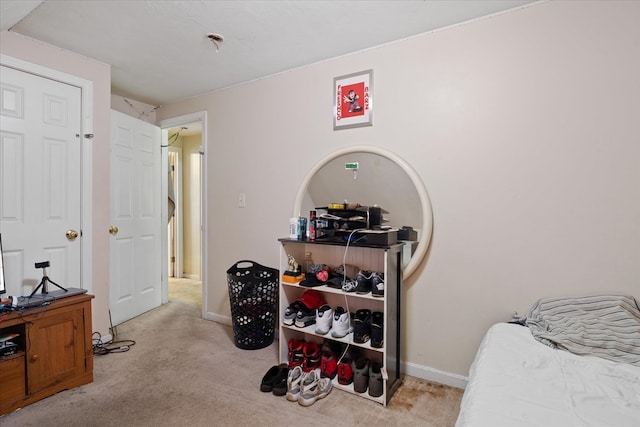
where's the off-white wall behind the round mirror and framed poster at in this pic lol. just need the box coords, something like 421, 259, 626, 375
158, 1, 640, 377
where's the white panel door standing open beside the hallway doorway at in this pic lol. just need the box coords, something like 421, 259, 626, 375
109, 110, 161, 325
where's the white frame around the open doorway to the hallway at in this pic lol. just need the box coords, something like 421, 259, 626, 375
157, 111, 208, 317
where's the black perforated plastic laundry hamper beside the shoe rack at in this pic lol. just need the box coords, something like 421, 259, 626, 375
227, 260, 279, 350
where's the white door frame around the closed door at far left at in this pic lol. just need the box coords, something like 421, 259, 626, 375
0, 54, 93, 293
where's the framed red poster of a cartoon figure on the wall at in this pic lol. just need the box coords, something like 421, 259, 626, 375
333, 70, 373, 130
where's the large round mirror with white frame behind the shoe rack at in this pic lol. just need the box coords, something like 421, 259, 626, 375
293, 145, 433, 279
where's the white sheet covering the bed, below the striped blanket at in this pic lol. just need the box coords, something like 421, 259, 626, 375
456, 323, 640, 427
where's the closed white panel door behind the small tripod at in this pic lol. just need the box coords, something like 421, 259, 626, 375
0, 66, 82, 295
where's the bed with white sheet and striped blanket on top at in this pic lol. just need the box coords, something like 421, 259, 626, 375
456, 295, 640, 427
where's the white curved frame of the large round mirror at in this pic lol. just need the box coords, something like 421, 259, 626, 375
293, 145, 433, 279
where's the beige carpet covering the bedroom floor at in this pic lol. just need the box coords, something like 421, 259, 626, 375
0, 281, 462, 427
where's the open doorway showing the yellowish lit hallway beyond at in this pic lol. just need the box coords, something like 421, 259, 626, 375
160, 115, 206, 316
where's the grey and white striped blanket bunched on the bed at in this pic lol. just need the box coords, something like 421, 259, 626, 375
522, 295, 640, 366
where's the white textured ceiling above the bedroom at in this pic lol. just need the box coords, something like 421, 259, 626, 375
0, 0, 532, 105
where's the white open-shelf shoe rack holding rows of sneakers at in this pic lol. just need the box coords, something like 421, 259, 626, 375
278, 238, 403, 406
